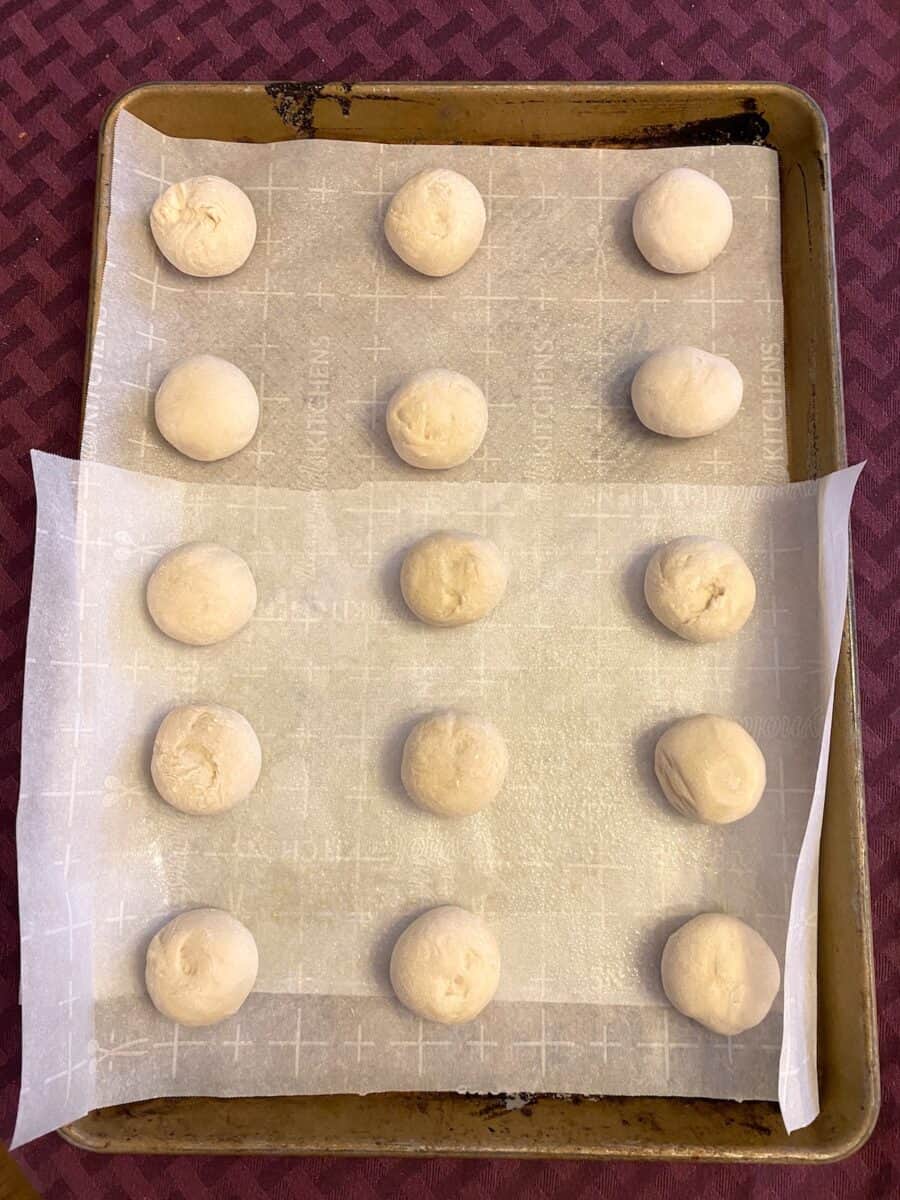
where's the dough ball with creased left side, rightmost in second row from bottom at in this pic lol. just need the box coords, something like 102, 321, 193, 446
653, 713, 766, 824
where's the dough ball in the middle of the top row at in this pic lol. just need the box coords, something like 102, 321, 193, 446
384, 167, 486, 275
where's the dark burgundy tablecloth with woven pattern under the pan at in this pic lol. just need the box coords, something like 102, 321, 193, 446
0, 0, 900, 1200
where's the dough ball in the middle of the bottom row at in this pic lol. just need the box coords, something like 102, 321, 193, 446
391, 905, 500, 1025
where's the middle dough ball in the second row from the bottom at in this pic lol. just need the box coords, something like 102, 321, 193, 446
400, 708, 509, 817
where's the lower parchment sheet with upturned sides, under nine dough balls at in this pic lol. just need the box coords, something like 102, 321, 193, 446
10, 455, 856, 1142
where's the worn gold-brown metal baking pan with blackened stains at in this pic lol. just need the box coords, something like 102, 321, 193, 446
60, 83, 878, 1163
